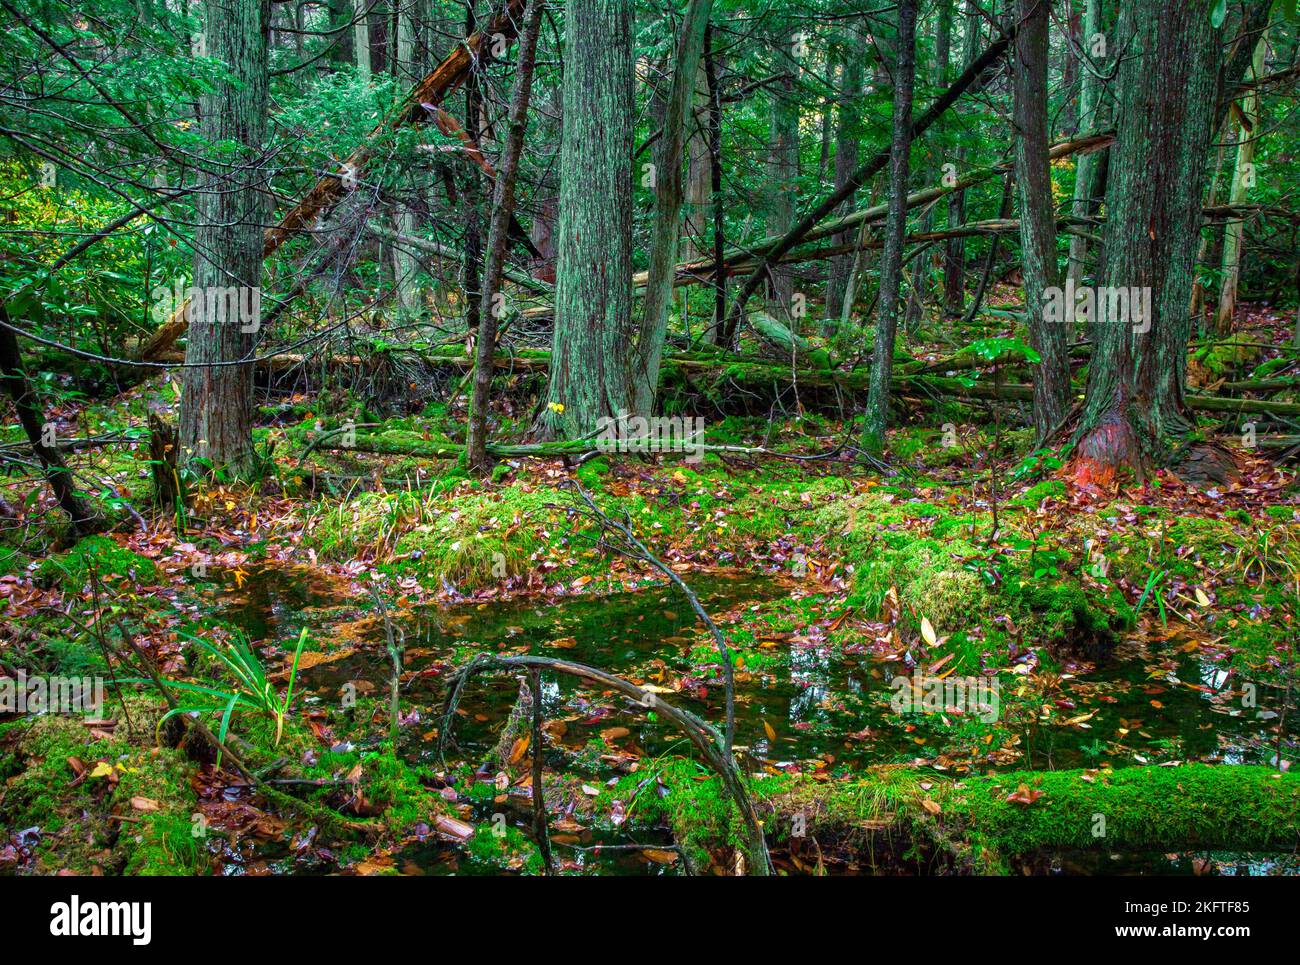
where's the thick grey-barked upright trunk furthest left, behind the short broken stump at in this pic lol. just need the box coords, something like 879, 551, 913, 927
181, 0, 270, 475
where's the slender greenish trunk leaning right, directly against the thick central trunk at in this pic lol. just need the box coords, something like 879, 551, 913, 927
632, 0, 712, 415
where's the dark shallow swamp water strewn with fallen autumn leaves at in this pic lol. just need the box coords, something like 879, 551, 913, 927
195, 568, 1300, 874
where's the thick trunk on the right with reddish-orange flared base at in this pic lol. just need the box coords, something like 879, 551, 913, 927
1074, 0, 1219, 485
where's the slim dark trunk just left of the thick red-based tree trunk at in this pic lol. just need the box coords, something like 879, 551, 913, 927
1011, 0, 1070, 443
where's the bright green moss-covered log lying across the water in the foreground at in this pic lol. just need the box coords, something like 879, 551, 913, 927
766, 763, 1300, 874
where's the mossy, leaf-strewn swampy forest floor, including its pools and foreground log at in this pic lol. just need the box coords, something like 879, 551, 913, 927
0, 296, 1300, 874
